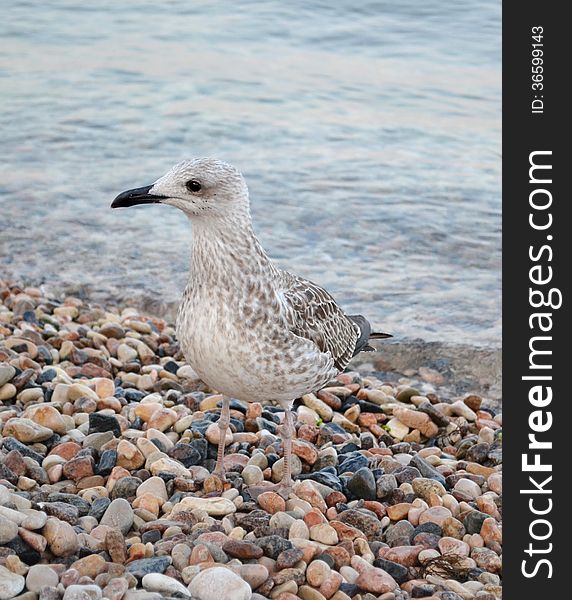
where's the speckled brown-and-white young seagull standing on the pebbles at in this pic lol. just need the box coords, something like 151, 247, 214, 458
111, 158, 391, 498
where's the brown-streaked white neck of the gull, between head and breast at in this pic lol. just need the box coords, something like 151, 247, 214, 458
190, 214, 278, 286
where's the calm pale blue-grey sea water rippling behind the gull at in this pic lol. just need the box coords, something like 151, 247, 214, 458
0, 0, 501, 346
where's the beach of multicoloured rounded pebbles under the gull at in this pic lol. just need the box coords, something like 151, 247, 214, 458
0, 280, 502, 600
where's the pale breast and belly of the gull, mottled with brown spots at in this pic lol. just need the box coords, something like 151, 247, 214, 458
177, 290, 335, 401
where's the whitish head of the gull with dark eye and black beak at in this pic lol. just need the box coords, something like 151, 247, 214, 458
111, 158, 248, 218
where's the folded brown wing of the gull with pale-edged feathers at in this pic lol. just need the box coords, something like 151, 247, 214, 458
282, 272, 359, 371
